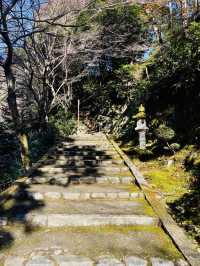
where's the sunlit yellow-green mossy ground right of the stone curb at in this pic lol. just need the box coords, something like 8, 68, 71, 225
122, 145, 200, 244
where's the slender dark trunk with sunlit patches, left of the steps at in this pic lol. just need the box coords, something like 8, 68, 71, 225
4, 67, 30, 171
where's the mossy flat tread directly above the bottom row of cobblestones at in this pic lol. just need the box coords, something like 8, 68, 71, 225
5, 225, 181, 260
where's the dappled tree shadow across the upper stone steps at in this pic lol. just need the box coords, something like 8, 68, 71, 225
28, 135, 119, 187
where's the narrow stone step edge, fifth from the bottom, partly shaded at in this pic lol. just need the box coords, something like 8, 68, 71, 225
38, 165, 129, 175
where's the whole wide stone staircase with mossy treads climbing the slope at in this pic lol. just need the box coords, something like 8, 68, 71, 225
0, 133, 188, 266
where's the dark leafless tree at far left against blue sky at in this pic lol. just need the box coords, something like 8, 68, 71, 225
0, 0, 86, 168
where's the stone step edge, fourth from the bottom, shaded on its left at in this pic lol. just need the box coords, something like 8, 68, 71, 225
29, 173, 134, 186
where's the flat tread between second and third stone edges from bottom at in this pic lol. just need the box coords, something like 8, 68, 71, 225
0, 197, 155, 218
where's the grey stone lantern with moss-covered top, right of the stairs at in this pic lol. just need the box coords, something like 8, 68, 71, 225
135, 104, 149, 150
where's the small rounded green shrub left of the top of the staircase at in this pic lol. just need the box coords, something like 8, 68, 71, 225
50, 108, 77, 137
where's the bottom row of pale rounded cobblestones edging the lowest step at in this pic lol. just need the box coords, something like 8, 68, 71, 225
3, 255, 188, 266
